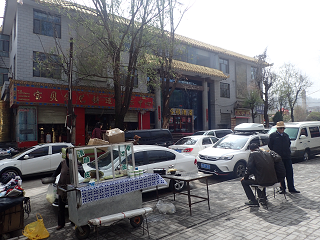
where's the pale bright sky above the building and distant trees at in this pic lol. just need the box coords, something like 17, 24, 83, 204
0, 0, 320, 102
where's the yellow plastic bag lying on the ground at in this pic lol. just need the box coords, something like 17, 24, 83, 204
22, 213, 50, 240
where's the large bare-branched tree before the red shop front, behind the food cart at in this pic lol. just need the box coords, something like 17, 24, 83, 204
39, 0, 182, 129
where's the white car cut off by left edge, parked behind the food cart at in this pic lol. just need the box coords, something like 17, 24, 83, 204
0, 143, 73, 177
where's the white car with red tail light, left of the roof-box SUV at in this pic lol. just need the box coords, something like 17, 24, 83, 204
169, 135, 219, 157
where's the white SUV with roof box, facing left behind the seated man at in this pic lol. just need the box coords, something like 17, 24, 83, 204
197, 133, 269, 177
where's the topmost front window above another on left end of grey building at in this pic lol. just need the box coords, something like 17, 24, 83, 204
33, 10, 61, 38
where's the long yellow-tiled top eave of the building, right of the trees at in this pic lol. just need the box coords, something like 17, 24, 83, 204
175, 34, 257, 63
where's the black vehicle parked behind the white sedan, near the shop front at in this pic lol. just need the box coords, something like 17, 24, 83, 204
125, 129, 174, 147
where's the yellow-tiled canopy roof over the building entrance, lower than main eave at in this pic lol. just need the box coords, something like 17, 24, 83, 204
172, 60, 228, 79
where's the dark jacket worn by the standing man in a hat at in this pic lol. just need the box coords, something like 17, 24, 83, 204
268, 132, 291, 159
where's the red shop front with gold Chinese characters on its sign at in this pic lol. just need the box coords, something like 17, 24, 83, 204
9, 80, 154, 148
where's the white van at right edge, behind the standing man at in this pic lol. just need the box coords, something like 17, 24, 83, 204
268, 121, 320, 160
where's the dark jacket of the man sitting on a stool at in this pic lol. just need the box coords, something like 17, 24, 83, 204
244, 150, 281, 186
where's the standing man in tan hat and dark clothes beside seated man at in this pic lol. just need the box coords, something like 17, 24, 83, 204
268, 121, 300, 194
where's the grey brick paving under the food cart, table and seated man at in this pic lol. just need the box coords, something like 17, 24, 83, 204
5, 158, 310, 240
